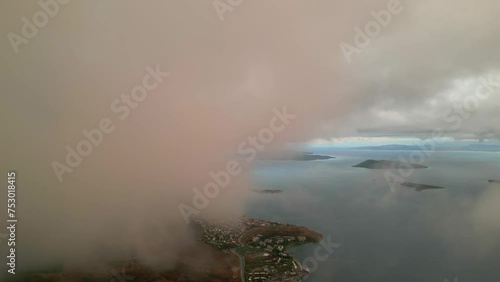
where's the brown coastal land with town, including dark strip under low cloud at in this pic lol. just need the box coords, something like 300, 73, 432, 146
12, 217, 323, 282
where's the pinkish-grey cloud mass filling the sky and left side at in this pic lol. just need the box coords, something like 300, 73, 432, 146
0, 0, 500, 276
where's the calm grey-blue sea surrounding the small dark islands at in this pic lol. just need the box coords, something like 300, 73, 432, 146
247, 148, 500, 282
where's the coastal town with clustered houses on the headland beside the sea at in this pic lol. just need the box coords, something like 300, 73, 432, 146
195, 217, 322, 281
